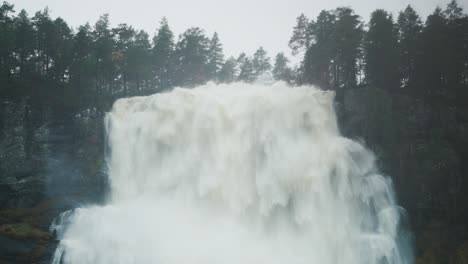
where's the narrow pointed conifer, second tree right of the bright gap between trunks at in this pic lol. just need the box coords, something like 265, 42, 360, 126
397, 5, 423, 87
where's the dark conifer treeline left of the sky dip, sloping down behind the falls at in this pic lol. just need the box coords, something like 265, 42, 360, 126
0, 2, 278, 111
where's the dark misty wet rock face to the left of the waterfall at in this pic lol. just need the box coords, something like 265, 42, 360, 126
0, 101, 106, 263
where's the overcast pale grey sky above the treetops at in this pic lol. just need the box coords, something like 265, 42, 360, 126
8, 0, 468, 59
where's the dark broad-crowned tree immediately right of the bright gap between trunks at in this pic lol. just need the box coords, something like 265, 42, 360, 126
364, 9, 400, 90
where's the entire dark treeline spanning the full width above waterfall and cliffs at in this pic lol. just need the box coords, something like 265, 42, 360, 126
0, 1, 468, 111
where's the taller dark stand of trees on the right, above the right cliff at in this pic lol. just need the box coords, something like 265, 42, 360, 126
289, 1, 468, 104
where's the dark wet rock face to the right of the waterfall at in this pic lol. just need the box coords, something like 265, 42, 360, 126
338, 88, 468, 263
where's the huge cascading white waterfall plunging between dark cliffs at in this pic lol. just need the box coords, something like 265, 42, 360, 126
53, 83, 412, 264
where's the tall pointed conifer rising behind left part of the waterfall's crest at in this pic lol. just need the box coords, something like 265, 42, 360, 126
152, 17, 174, 89
